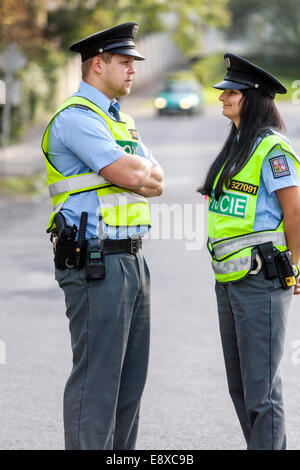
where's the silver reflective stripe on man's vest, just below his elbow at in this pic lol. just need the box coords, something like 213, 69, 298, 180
49, 173, 106, 197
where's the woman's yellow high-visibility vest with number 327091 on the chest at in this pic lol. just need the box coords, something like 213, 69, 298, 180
207, 133, 300, 282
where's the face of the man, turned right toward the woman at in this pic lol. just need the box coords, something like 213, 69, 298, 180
101, 54, 135, 99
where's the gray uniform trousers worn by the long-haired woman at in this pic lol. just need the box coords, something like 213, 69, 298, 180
216, 271, 293, 450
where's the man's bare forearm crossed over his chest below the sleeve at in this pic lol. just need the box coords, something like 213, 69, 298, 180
99, 154, 164, 197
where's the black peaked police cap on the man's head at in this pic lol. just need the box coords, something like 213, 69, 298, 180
70, 22, 145, 62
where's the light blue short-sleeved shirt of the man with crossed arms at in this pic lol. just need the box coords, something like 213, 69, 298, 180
49, 81, 156, 239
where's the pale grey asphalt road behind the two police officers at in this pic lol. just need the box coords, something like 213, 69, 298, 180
0, 101, 300, 450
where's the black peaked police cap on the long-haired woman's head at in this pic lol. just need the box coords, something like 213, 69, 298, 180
214, 53, 287, 98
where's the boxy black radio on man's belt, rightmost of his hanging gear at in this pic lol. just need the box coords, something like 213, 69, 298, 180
85, 237, 105, 280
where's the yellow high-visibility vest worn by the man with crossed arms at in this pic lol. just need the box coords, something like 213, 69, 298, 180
42, 96, 150, 232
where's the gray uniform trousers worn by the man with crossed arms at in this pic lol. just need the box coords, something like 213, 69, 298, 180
55, 252, 150, 450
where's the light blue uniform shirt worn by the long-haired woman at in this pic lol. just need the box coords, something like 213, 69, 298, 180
253, 131, 300, 231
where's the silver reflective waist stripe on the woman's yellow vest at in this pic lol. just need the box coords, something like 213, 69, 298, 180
209, 232, 286, 259
